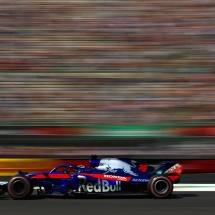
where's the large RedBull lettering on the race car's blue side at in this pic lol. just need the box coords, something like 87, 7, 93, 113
78, 176, 121, 193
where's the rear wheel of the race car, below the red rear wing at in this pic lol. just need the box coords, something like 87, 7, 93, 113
147, 175, 173, 199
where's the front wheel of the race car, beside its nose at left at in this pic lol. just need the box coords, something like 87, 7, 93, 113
7, 175, 32, 199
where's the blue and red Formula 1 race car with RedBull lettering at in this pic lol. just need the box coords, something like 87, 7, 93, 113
0, 155, 183, 199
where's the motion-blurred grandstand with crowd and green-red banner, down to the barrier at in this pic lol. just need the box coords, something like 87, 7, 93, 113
0, 0, 215, 174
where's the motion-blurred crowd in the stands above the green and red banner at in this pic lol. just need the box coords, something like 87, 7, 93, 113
0, 0, 215, 125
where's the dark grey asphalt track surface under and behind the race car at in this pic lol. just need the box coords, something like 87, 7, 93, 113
0, 174, 215, 215
